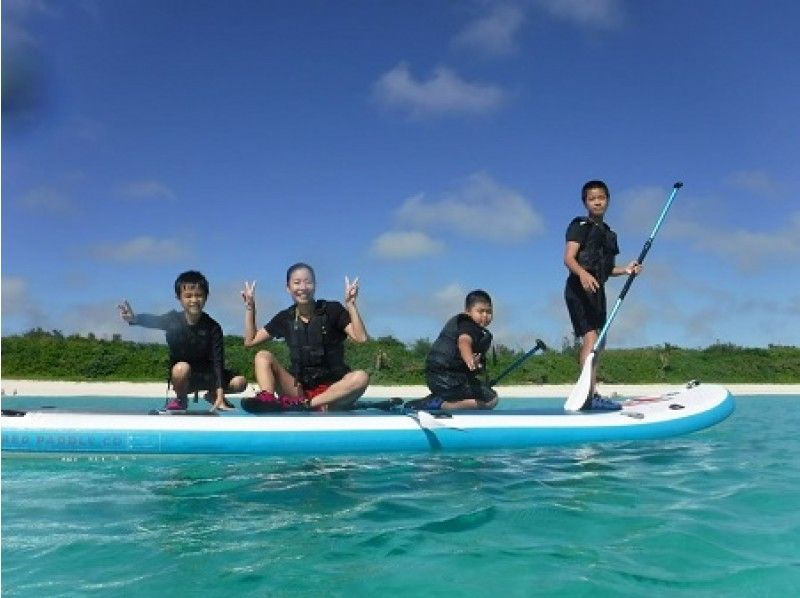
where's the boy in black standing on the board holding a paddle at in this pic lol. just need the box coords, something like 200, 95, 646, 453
564, 181, 641, 410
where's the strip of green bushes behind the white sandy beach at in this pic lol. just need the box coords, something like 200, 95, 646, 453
2, 329, 800, 384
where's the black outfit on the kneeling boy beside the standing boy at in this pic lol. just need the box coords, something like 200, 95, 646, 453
425, 313, 495, 401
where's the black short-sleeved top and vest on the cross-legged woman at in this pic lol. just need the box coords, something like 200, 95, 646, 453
264, 300, 350, 390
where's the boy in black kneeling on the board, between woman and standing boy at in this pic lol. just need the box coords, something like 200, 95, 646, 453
407, 290, 497, 409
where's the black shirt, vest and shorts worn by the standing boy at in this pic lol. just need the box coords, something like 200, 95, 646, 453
564, 216, 619, 336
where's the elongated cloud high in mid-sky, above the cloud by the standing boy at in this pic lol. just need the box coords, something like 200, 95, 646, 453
374, 64, 505, 118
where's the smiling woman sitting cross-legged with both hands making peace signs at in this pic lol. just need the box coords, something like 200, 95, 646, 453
242, 263, 369, 411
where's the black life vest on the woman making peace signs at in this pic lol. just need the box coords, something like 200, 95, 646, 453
286, 300, 350, 390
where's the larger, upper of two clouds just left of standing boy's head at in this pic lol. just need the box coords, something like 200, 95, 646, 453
396, 173, 544, 242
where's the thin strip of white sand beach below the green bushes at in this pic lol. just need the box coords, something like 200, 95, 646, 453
2, 379, 800, 399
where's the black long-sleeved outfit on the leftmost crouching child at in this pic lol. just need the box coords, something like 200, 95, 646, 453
130, 310, 225, 388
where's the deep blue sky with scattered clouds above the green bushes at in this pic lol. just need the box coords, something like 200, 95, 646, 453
2, 0, 800, 348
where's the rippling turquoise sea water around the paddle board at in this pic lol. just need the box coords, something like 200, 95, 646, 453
2, 396, 800, 598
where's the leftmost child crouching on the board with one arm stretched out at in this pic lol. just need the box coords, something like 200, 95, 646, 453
118, 270, 247, 411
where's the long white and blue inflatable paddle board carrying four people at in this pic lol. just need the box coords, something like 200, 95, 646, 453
0, 383, 734, 455
